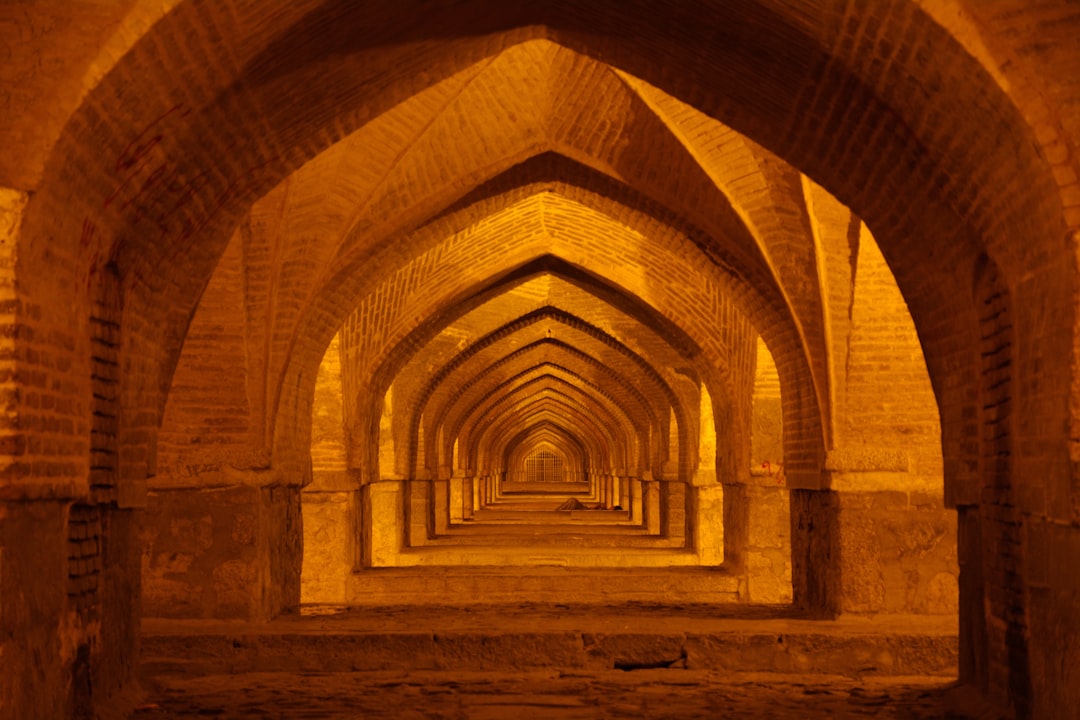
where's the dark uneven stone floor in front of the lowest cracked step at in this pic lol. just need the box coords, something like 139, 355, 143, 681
131, 669, 986, 720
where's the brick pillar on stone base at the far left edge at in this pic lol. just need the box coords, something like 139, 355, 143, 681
0, 188, 108, 718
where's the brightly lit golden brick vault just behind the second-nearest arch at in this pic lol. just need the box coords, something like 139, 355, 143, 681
285, 156, 813, 462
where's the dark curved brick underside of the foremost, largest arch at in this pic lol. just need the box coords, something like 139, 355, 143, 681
18, 0, 1071, 496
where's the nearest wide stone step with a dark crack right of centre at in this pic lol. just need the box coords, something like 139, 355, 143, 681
141, 604, 958, 677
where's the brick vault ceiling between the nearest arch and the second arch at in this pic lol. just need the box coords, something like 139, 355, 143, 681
162, 42, 803, 472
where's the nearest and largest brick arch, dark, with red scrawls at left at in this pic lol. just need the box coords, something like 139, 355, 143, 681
21, 2, 1072, 505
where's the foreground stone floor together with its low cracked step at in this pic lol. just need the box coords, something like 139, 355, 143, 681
127, 603, 993, 720
